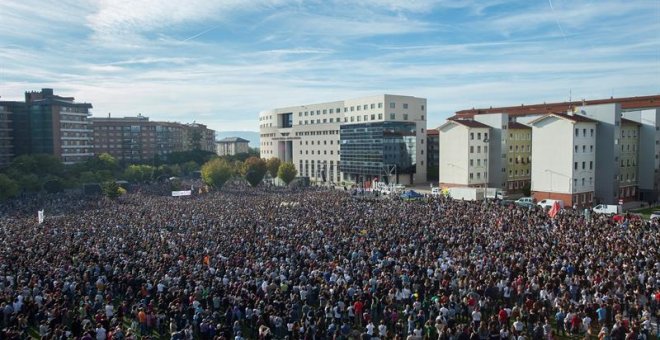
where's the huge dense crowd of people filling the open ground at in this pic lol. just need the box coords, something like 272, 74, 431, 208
0, 188, 660, 340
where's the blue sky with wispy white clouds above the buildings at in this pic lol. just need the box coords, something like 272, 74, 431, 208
0, 0, 660, 131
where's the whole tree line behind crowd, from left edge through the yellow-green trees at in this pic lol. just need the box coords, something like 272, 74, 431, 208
0, 150, 297, 201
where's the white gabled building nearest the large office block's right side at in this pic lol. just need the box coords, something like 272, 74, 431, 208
438, 119, 491, 187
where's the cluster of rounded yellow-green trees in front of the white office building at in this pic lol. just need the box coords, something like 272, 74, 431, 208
201, 157, 298, 189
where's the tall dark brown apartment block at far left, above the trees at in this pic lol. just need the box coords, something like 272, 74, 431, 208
7, 89, 94, 164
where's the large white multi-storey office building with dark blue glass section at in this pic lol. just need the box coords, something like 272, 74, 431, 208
259, 94, 426, 184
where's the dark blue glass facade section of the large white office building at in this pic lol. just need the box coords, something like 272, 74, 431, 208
340, 121, 417, 180
